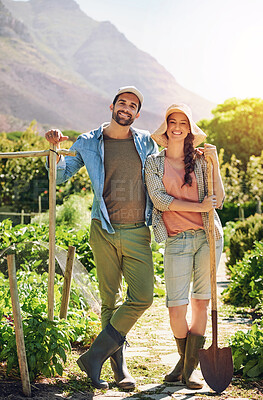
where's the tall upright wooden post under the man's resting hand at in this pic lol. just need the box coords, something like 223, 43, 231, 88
48, 144, 57, 321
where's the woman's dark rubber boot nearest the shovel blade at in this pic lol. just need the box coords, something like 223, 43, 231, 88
183, 333, 205, 389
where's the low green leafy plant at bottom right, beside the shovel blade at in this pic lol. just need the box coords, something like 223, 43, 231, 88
229, 324, 263, 378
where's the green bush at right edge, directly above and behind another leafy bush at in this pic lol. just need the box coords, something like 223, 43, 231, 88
227, 214, 263, 266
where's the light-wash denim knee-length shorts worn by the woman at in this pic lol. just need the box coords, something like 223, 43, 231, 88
164, 229, 223, 307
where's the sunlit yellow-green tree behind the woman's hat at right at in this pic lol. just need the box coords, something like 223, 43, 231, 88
198, 98, 263, 170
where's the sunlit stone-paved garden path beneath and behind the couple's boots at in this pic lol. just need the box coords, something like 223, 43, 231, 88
94, 254, 260, 400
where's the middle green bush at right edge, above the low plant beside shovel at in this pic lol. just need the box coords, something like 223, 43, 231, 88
223, 242, 263, 307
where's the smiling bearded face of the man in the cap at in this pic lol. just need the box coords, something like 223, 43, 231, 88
110, 93, 140, 126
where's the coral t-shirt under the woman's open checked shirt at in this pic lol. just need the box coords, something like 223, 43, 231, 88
162, 158, 204, 236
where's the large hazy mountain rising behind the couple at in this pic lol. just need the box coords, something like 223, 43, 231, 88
0, 0, 214, 133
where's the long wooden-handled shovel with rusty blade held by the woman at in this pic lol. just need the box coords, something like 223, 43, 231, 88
199, 158, 233, 393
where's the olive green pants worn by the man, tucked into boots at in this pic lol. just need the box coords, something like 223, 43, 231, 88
90, 219, 154, 336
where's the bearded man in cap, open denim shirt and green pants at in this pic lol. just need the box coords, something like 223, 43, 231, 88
45, 86, 157, 389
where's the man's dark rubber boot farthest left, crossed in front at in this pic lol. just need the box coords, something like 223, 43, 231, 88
77, 324, 125, 389
